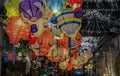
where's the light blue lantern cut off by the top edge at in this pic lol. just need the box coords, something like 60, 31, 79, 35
46, 0, 66, 13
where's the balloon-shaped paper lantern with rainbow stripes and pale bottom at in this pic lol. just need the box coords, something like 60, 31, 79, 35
57, 9, 82, 38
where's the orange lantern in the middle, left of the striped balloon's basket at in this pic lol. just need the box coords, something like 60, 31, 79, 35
38, 28, 53, 56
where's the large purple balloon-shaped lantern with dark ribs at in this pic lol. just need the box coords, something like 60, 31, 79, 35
19, 0, 45, 22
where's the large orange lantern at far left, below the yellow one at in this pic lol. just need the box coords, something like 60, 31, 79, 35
4, 16, 30, 44
